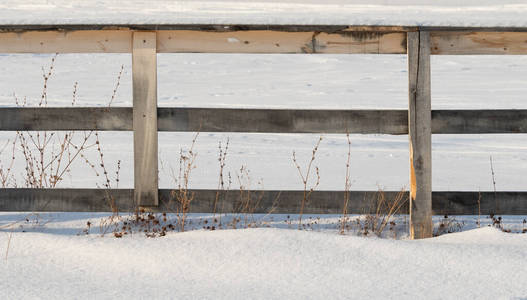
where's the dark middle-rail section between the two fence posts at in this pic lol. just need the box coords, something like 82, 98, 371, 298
158, 108, 408, 134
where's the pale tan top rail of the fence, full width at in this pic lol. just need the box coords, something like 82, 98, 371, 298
0, 24, 527, 55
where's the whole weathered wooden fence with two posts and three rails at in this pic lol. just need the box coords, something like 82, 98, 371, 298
0, 25, 527, 238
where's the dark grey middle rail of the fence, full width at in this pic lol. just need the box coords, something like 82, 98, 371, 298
0, 107, 527, 135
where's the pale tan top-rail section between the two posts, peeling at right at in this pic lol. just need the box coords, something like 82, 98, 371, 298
157, 30, 406, 54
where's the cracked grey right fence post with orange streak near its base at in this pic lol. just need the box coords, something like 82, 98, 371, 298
407, 31, 432, 239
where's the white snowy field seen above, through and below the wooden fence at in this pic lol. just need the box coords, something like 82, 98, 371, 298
0, 0, 527, 299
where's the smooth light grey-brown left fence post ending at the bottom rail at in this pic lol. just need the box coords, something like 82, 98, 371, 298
132, 31, 159, 206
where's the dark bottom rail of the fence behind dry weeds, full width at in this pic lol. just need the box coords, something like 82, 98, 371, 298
0, 188, 527, 215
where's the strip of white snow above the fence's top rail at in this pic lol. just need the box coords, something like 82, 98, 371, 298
0, 0, 527, 27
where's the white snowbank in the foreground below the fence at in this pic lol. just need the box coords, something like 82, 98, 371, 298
0, 213, 527, 299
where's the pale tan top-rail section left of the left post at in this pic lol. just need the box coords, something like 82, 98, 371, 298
0, 30, 132, 53
